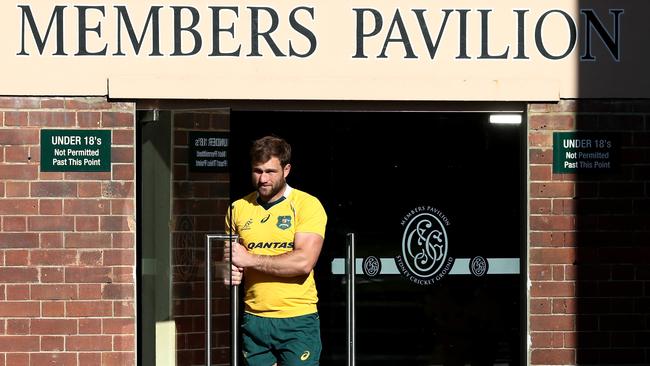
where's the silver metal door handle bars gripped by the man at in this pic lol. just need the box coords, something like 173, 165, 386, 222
205, 234, 239, 366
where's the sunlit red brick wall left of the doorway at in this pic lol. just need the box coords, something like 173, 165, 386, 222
0, 97, 135, 366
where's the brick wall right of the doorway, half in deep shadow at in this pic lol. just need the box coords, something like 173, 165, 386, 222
528, 101, 650, 365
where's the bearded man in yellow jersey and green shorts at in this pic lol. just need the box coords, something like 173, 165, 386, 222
224, 136, 327, 366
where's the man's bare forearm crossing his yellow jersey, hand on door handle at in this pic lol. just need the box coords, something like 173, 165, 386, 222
224, 233, 323, 277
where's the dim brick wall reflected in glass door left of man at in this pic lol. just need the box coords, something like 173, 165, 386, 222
172, 112, 230, 366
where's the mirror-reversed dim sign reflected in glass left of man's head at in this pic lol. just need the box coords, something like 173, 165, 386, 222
189, 131, 230, 173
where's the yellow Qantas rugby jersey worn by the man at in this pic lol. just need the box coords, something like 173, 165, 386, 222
226, 185, 327, 318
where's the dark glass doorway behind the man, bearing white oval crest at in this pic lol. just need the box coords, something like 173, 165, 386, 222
230, 111, 525, 365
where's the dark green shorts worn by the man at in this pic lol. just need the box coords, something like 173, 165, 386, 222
241, 313, 322, 366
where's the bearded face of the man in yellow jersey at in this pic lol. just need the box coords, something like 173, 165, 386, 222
252, 157, 291, 202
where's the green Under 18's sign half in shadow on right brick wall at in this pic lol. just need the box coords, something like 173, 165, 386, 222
553, 132, 620, 173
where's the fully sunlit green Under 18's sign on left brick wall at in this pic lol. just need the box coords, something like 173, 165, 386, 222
41, 130, 111, 172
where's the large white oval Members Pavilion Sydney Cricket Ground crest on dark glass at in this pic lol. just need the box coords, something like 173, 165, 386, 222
395, 206, 454, 285
